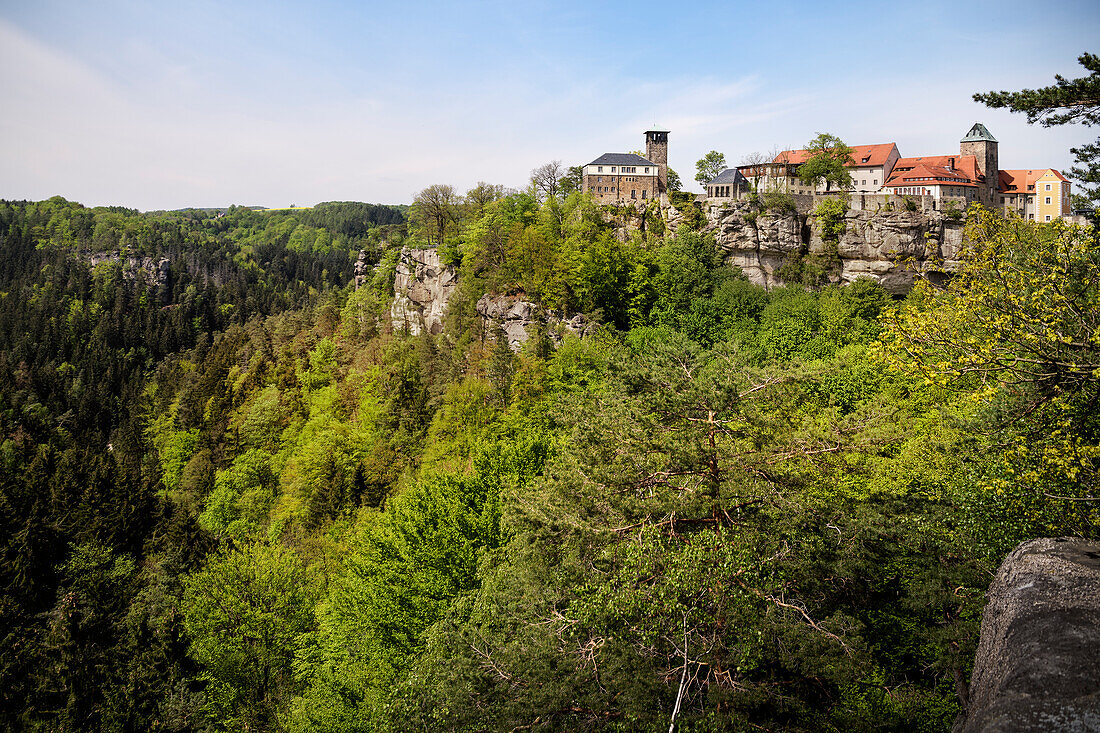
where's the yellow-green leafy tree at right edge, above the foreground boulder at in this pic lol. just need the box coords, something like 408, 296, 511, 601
884, 212, 1100, 553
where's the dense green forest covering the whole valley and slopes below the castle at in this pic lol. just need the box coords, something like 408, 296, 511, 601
0, 191, 1100, 732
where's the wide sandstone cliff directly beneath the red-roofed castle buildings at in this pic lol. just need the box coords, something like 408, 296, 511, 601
706, 201, 963, 295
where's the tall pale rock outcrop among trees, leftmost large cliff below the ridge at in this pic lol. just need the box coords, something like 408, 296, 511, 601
389, 249, 459, 336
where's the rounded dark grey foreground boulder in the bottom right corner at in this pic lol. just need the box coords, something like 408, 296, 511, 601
955, 538, 1100, 733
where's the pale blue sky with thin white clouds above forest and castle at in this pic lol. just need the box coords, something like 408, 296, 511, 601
0, 0, 1100, 209
